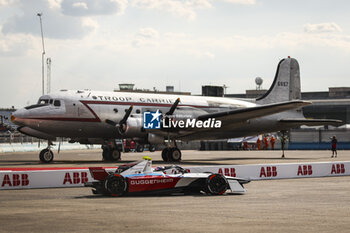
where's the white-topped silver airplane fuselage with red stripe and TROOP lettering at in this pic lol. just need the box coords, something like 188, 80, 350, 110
12, 90, 302, 140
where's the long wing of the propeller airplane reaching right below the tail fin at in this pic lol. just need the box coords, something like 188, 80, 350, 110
198, 100, 311, 124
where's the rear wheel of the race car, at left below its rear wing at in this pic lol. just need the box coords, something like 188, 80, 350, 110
104, 174, 128, 197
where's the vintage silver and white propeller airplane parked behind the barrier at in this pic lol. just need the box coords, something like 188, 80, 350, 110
11, 57, 341, 163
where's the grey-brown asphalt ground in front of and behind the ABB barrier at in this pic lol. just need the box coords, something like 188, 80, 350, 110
0, 150, 350, 233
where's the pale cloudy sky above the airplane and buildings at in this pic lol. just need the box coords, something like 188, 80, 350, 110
0, 0, 350, 108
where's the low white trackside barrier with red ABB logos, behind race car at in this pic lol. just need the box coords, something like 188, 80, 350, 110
0, 162, 350, 190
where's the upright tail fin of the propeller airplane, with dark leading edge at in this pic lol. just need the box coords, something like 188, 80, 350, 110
256, 57, 301, 104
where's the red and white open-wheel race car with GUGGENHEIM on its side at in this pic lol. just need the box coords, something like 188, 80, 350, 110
85, 158, 249, 196
